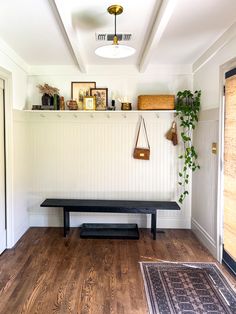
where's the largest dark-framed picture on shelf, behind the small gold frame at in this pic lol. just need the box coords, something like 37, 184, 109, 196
71, 82, 96, 110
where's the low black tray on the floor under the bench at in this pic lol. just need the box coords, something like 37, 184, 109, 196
80, 223, 139, 240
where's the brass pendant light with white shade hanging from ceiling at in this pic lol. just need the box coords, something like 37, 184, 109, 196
95, 5, 136, 59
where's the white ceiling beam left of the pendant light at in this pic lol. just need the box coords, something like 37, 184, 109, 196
50, 0, 86, 73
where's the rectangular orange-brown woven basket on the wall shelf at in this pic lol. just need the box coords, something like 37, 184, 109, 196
138, 95, 175, 110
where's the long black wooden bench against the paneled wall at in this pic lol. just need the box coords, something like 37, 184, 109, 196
40, 198, 180, 240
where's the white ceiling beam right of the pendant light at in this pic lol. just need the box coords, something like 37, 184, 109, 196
139, 0, 177, 72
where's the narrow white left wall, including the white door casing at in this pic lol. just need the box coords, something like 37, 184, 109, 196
0, 40, 29, 247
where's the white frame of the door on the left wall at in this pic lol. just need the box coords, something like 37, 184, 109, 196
0, 67, 14, 248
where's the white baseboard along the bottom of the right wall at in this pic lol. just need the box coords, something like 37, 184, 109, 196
191, 218, 217, 258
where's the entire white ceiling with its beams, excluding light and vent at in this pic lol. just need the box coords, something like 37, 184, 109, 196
0, 0, 236, 70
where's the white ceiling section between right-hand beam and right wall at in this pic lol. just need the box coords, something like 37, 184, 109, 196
150, 0, 236, 64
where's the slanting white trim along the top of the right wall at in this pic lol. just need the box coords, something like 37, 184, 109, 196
193, 22, 236, 73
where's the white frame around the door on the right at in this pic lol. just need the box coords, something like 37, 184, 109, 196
217, 58, 236, 263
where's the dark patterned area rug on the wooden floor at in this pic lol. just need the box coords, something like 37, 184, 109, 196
140, 262, 236, 314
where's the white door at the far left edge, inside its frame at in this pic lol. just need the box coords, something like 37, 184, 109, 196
0, 79, 6, 254
